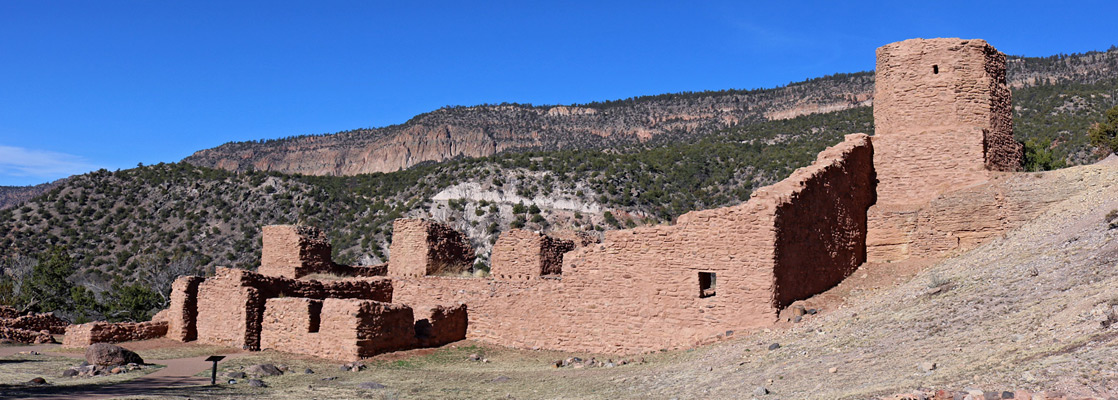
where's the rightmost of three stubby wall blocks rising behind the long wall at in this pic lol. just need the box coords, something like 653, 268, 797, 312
490, 229, 575, 280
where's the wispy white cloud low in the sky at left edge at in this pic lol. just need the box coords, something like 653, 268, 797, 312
0, 145, 101, 180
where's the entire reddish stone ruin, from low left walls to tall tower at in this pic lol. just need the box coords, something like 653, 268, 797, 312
65, 39, 1024, 360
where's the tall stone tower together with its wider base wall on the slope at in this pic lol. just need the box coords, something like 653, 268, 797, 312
866, 39, 1031, 263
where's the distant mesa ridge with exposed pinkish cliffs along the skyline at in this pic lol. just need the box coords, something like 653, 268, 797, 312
182, 47, 1118, 175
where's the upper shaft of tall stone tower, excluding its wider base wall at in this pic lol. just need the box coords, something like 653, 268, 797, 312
873, 39, 1022, 204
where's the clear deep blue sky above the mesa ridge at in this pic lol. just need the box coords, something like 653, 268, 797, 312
0, 0, 1118, 185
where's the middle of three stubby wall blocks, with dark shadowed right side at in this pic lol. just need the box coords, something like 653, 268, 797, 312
388, 219, 476, 277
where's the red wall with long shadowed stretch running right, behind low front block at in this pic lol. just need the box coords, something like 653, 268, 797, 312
196, 268, 392, 350
